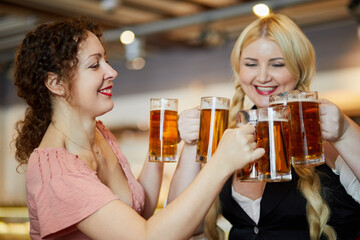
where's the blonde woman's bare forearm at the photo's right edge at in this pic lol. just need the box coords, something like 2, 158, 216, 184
332, 116, 360, 180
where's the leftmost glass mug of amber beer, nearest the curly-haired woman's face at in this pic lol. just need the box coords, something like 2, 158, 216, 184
148, 98, 178, 162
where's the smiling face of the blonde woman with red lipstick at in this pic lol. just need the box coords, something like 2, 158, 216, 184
239, 38, 296, 108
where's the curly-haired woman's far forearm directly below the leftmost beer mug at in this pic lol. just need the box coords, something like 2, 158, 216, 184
138, 160, 163, 219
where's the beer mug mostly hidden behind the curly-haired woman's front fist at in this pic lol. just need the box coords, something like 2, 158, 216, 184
235, 109, 258, 181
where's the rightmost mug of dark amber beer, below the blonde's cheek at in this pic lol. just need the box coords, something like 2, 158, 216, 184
287, 92, 325, 167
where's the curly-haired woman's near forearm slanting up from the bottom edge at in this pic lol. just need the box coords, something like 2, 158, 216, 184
148, 158, 231, 239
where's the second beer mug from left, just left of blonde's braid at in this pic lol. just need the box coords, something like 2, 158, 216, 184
196, 97, 230, 163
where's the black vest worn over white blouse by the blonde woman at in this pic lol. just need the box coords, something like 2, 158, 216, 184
220, 164, 360, 240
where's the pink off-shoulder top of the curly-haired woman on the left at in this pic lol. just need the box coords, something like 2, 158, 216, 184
26, 121, 145, 240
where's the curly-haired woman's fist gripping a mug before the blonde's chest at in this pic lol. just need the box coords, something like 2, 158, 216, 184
210, 124, 265, 172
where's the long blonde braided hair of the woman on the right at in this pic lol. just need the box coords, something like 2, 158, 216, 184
205, 14, 336, 239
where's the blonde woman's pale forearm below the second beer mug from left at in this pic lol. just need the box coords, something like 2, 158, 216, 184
168, 144, 201, 203
